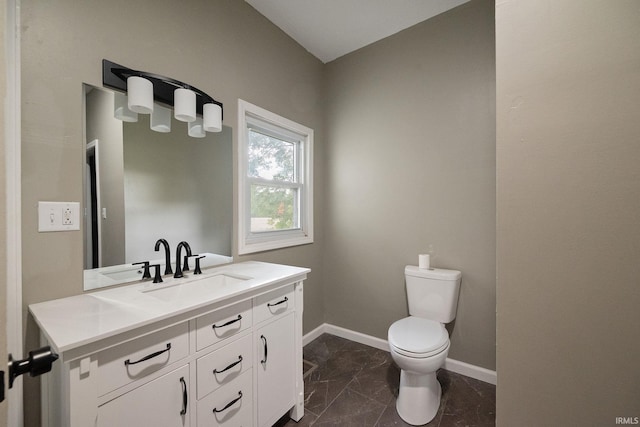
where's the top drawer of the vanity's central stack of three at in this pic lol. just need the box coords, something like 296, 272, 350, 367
196, 301, 251, 350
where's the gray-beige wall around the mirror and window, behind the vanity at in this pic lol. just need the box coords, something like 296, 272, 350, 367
21, 0, 324, 426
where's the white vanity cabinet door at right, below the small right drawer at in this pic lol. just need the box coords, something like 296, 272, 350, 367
254, 313, 296, 426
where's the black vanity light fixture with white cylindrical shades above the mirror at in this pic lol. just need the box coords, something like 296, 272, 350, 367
102, 59, 223, 138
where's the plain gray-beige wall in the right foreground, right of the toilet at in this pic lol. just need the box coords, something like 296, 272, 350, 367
496, 0, 640, 426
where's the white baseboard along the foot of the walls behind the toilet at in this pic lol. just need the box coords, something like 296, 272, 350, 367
302, 323, 498, 385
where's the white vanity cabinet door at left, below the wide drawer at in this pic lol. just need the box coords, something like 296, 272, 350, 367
97, 365, 190, 427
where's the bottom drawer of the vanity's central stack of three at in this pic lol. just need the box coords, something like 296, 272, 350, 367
197, 369, 253, 427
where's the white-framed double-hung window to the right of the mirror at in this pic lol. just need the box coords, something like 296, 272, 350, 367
238, 100, 313, 254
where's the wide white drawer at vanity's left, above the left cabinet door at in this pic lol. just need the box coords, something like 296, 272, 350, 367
98, 323, 189, 396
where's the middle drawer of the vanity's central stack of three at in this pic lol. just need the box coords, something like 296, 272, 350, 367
197, 335, 253, 399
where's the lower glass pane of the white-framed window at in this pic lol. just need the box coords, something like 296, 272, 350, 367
251, 185, 299, 233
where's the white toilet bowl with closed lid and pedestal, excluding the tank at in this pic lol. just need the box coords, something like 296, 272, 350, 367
388, 316, 449, 425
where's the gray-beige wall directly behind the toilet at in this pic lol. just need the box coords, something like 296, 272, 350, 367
324, 0, 495, 369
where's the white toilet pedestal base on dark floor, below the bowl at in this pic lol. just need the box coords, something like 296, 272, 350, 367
396, 369, 442, 425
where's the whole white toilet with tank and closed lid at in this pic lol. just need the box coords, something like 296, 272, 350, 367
388, 265, 462, 425
